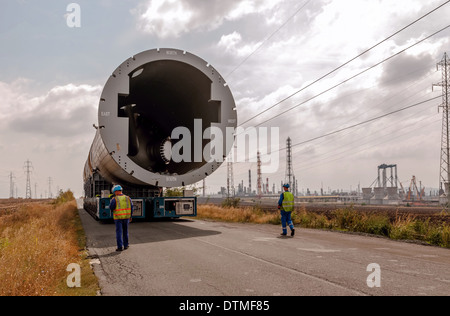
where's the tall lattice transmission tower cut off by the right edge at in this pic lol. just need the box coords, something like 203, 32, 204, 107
433, 53, 450, 203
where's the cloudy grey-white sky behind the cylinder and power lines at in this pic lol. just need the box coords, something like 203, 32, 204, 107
0, 0, 450, 198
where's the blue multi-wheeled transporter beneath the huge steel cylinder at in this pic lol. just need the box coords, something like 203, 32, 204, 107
84, 197, 197, 221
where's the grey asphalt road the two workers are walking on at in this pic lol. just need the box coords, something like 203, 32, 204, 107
80, 210, 450, 296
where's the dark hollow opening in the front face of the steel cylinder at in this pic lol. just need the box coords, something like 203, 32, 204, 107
118, 60, 221, 175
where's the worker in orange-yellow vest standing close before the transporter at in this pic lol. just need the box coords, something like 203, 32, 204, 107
109, 185, 133, 251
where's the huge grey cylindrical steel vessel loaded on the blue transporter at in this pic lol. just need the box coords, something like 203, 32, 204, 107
84, 49, 237, 191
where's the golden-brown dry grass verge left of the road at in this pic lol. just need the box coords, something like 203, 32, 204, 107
0, 201, 98, 296
